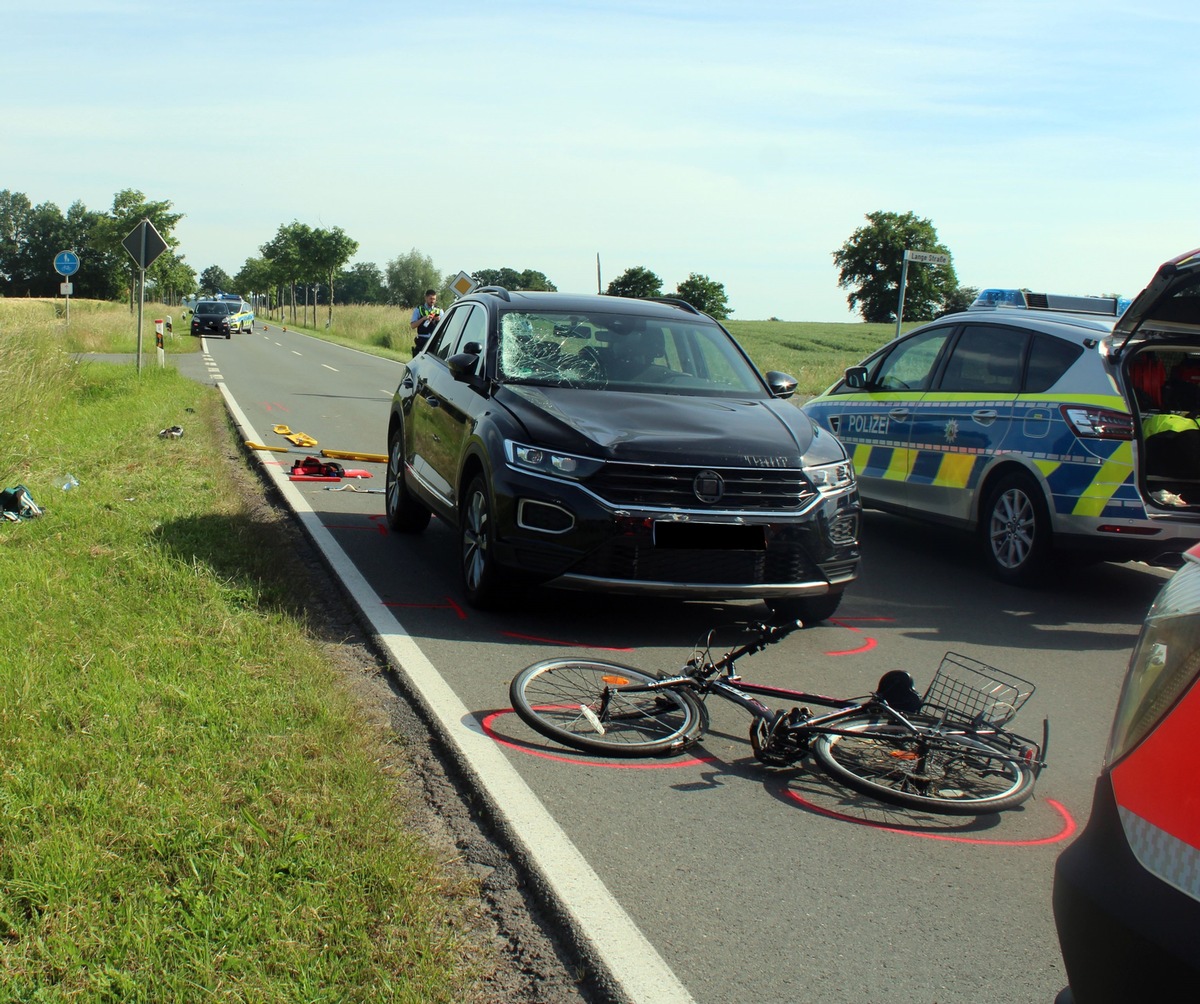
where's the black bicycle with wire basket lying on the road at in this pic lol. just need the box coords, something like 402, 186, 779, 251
509, 621, 1050, 816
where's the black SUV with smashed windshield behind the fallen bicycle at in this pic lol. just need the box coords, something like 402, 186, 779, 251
385, 287, 860, 621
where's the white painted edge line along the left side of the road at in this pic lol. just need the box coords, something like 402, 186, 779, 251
217, 383, 696, 1004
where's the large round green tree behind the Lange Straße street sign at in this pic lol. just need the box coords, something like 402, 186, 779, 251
833, 211, 959, 324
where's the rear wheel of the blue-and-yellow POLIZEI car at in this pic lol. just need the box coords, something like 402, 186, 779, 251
979, 473, 1050, 585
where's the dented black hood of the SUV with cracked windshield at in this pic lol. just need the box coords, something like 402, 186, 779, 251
497, 385, 814, 468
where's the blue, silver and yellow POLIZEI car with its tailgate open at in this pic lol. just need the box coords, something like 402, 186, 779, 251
804, 251, 1200, 584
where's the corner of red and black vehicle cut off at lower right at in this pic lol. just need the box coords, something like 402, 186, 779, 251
1054, 547, 1200, 1004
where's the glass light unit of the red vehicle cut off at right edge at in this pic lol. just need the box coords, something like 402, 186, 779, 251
1104, 548, 1200, 764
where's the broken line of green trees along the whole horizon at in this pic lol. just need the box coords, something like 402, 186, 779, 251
0, 188, 977, 324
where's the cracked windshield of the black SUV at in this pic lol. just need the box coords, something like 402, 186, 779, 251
499, 311, 768, 398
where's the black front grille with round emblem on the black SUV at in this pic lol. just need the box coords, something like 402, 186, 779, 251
587, 463, 817, 512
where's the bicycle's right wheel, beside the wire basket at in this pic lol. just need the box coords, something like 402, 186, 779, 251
812, 715, 1036, 816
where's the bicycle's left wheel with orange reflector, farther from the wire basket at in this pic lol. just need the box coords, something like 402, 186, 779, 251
509, 659, 704, 757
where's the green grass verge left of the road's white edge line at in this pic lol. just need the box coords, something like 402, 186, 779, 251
0, 300, 488, 1004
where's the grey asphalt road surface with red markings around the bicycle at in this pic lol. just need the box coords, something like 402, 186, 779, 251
187, 319, 1168, 1004
